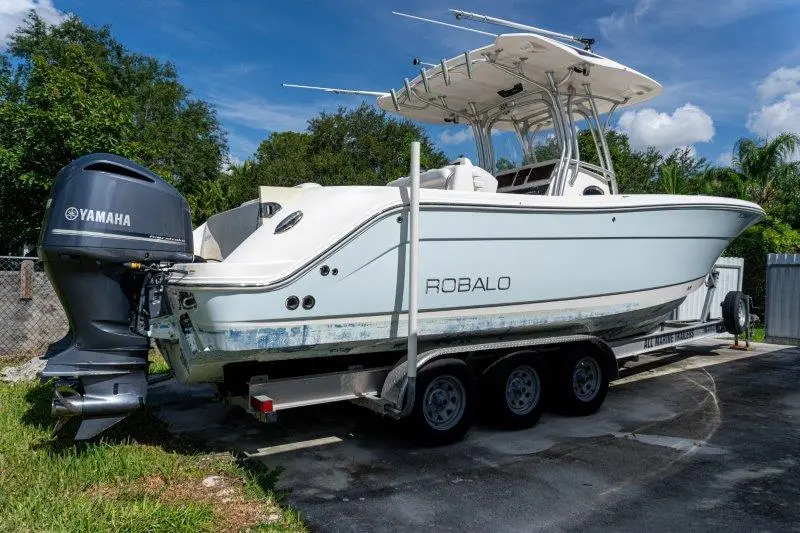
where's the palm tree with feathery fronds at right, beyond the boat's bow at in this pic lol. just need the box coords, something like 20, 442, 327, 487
700, 133, 800, 209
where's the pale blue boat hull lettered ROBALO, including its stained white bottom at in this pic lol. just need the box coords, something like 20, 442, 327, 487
158, 195, 760, 382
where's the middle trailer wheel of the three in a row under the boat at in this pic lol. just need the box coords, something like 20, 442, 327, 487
484, 354, 545, 429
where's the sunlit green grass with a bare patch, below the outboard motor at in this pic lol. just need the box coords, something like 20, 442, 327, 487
0, 364, 306, 531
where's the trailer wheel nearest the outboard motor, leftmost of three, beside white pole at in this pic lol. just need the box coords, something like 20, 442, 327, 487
407, 359, 474, 446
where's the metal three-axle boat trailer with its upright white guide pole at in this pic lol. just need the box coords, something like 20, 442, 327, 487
220, 143, 750, 444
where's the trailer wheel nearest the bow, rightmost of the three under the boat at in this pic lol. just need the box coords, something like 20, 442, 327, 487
554, 345, 608, 416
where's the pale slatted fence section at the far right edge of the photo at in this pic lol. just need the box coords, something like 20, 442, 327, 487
764, 254, 800, 344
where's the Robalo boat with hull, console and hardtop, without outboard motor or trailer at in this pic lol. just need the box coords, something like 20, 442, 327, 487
159, 23, 763, 382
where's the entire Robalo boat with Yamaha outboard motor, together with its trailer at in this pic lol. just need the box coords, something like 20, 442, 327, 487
40, 12, 764, 443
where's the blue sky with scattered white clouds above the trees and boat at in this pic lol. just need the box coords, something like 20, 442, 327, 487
0, 0, 800, 166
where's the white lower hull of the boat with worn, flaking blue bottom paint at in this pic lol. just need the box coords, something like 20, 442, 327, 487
161, 278, 703, 383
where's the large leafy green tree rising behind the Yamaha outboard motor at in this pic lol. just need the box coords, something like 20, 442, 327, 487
0, 13, 227, 252
